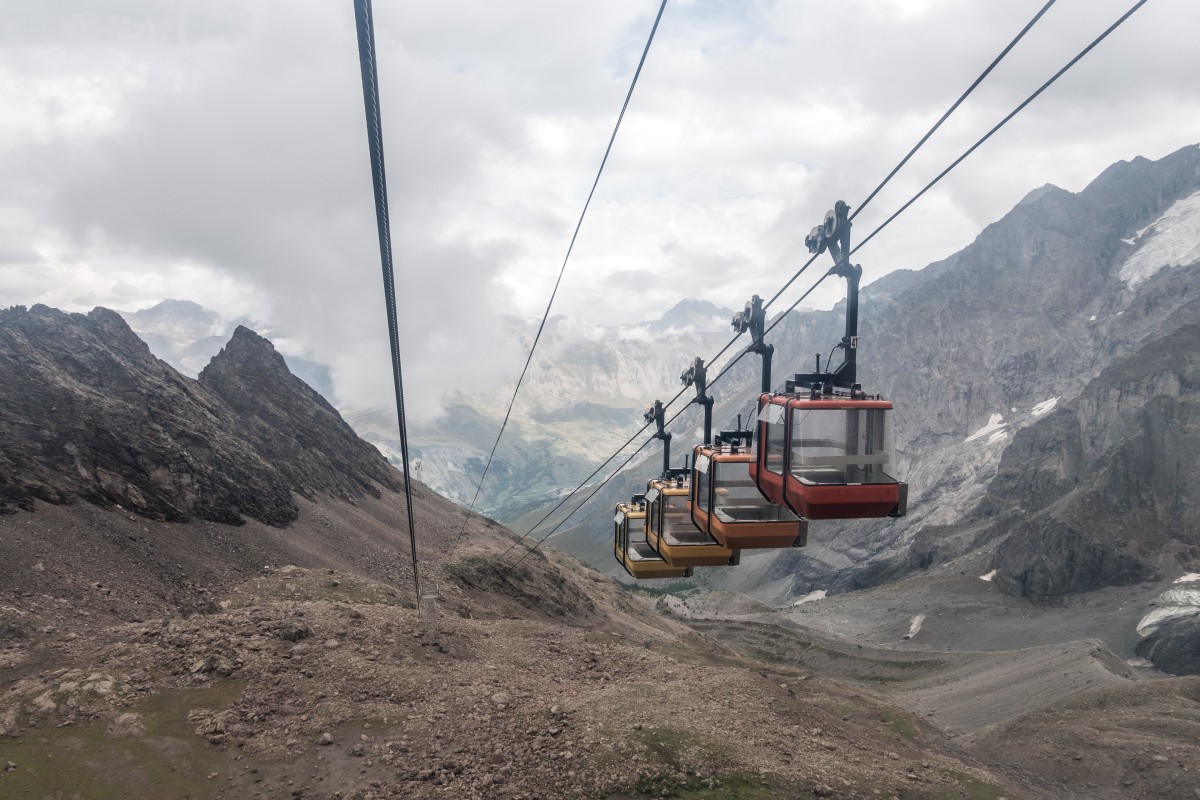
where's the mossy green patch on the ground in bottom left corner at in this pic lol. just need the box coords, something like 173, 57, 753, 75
0, 681, 244, 800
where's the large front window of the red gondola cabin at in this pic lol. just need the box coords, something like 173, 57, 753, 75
791, 408, 896, 483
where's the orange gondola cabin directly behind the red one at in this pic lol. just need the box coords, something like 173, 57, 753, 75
691, 441, 808, 549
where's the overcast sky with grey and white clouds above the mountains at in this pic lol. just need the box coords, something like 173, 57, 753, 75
0, 0, 1200, 419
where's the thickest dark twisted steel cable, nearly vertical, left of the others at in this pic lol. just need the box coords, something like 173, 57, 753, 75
354, 0, 421, 604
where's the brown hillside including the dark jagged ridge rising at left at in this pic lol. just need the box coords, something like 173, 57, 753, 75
0, 308, 1200, 800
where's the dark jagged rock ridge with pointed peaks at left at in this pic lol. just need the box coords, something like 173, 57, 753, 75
0, 306, 398, 525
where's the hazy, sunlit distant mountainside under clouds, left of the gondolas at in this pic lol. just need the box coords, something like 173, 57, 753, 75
360, 300, 733, 523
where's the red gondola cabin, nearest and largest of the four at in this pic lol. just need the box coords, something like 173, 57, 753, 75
750, 392, 908, 519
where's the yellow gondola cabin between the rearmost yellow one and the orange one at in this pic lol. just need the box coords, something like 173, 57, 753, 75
646, 469, 737, 567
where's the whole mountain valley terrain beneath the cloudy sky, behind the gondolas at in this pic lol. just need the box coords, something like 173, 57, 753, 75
0, 146, 1200, 800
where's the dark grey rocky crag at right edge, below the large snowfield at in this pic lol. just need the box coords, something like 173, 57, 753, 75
980, 321, 1200, 596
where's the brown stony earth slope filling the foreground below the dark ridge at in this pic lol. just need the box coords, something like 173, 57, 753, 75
0, 494, 1032, 798
